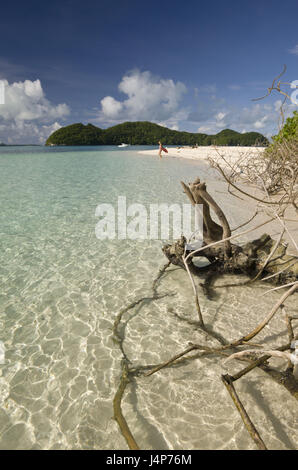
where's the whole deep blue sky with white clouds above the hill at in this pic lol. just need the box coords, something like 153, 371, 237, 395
0, 0, 298, 144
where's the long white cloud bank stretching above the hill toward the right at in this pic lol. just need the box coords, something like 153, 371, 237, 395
96, 70, 293, 136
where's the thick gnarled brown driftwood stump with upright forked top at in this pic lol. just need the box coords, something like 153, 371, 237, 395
163, 178, 298, 283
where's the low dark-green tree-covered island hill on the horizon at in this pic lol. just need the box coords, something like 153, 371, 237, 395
46, 121, 268, 146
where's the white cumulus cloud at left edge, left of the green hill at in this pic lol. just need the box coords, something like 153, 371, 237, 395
0, 79, 70, 143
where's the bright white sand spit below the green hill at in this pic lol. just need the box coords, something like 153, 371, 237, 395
138, 146, 265, 169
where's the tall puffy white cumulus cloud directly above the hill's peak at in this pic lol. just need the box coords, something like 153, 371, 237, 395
99, 70, 187, 121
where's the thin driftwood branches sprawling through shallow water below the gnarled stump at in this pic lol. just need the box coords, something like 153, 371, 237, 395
113, 263, 298, 450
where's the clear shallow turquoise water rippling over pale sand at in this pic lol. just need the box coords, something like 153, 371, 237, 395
0, 147, 298, 449
